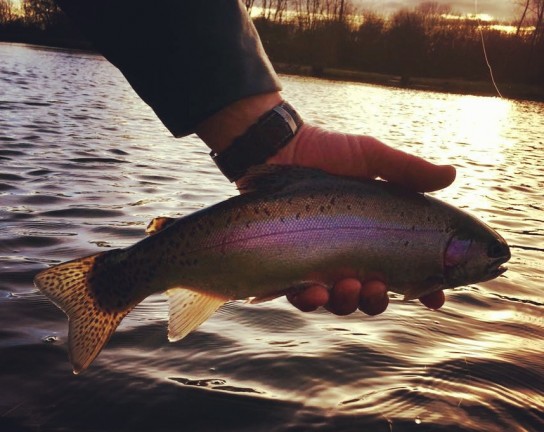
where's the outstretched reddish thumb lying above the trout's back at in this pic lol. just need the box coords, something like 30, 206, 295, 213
365, 140, 456, 192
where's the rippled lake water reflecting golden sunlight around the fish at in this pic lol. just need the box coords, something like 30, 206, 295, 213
0, 44, 544, 432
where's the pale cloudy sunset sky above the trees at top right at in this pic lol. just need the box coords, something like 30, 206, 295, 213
360, 0, 517, 20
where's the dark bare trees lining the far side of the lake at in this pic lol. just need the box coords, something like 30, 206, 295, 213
0, 0, 544, 85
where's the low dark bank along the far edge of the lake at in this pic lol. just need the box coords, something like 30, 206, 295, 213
0, 35, 544, 102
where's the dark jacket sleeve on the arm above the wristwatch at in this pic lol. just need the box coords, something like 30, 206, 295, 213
58, 0, 281, 136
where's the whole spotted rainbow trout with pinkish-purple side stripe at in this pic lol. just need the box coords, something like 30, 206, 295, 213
34, 166, 510, 373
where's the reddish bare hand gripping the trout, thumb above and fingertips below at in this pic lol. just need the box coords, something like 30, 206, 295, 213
267, 125, 455, 315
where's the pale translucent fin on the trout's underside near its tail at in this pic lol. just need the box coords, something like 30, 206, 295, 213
166, 288, 229, 342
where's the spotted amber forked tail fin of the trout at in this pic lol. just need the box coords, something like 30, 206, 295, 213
34, 250, 134, 374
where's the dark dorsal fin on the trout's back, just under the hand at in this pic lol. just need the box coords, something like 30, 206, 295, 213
238, 164, 331, 192
